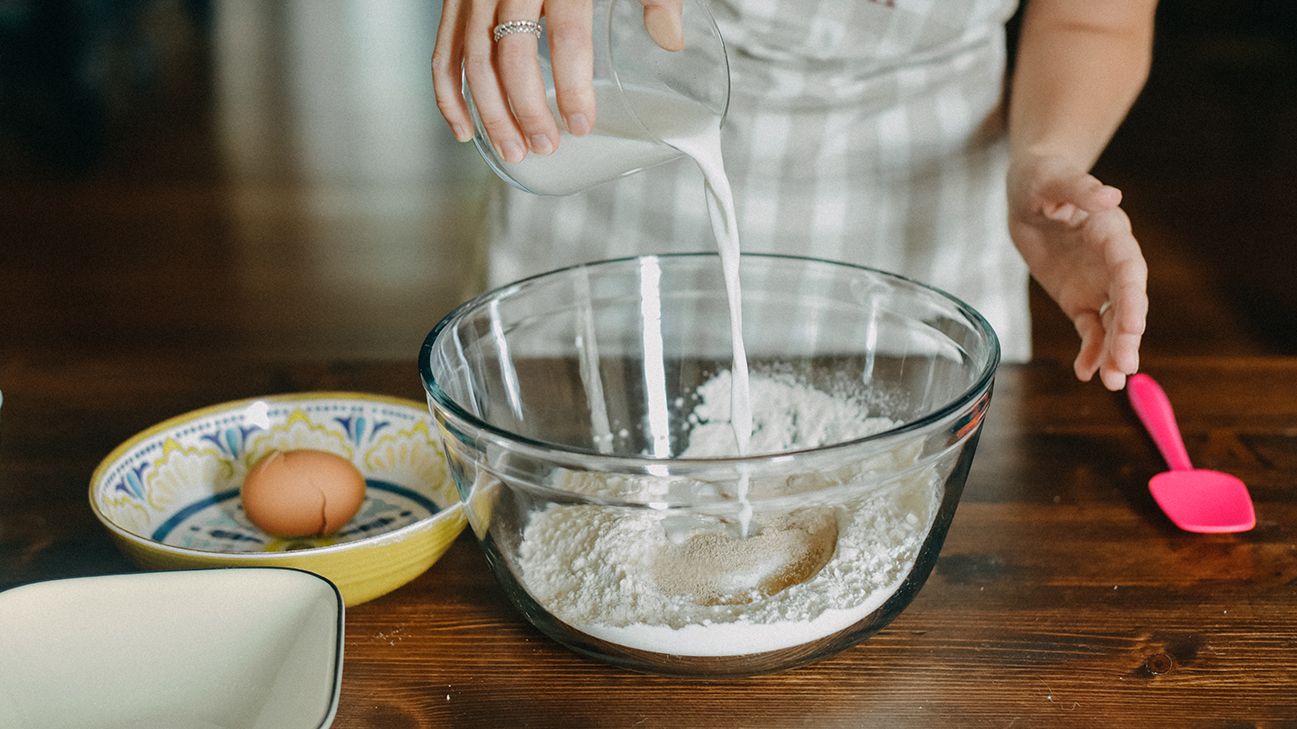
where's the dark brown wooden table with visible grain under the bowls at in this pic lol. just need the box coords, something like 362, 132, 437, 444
0, 354, 1297, 729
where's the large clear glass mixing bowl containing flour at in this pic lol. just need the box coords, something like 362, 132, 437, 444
419, 254, 1000, 676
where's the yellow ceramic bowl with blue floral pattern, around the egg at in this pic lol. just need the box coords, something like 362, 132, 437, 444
89, 392, 464, 606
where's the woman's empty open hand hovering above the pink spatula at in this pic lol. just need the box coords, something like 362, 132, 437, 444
1008, 154, 1148, 390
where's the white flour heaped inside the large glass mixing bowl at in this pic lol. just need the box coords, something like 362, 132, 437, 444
519, 374, 940, 656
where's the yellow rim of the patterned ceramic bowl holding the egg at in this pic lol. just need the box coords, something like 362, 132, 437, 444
88, 390, 463, 555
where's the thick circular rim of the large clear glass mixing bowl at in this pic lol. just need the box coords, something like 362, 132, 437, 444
419, 250, 1001, 464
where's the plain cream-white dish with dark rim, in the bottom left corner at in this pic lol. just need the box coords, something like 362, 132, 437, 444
0, 567, 344, 729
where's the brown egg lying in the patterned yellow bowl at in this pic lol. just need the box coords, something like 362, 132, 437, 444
241, 450, 364, 537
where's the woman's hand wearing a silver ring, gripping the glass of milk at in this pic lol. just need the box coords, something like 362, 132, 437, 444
432, 0, 684, 162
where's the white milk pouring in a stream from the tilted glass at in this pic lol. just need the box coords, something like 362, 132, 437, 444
505, 83, 752, 526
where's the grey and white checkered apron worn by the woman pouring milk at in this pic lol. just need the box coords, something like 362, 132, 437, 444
488, 0, 1031, 362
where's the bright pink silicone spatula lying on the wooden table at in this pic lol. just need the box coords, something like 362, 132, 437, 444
1126, 374, 1257, 532
